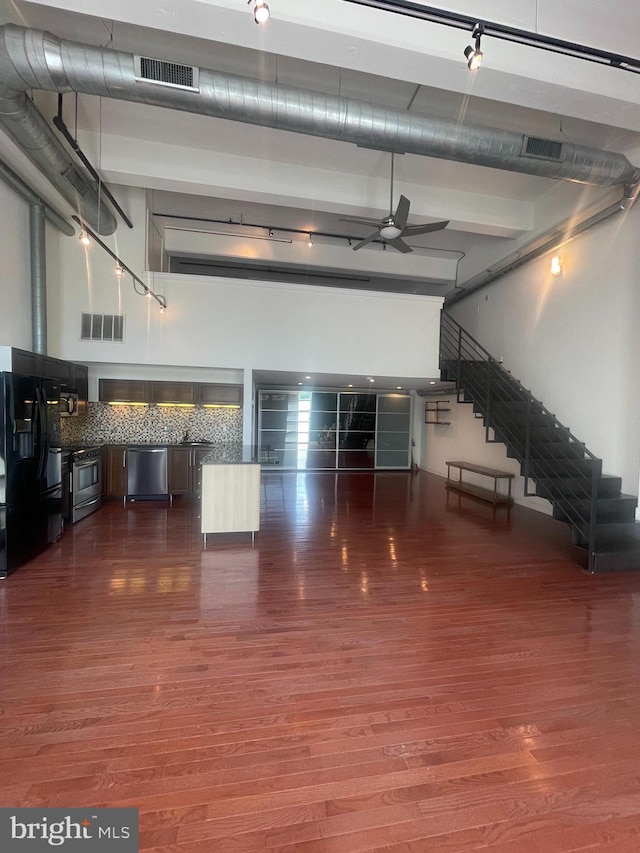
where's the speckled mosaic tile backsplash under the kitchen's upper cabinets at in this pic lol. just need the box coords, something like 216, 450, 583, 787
62, 403, 242, 446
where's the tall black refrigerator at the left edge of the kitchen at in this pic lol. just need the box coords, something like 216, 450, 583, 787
0, 373, 62, 579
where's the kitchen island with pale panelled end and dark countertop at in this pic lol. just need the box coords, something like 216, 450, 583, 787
200, 449, 260, 546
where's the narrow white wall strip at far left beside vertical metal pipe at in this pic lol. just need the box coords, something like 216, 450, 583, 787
0, 181, 31, 349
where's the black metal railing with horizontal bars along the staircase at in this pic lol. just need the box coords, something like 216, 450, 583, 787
440, 312, 602, 571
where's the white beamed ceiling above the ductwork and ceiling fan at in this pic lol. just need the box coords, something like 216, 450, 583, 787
0, 0, 640, 386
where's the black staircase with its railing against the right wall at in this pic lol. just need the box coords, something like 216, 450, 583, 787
440, 312, 640, 573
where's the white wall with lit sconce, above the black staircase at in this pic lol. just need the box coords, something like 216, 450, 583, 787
451, 205, 640, 494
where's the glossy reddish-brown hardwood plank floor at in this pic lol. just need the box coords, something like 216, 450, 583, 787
0, 473, 640, 853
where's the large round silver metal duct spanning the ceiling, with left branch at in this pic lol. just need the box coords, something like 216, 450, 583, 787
0, 24, 637, 234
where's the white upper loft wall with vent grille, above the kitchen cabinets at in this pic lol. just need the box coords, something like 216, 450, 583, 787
53, 190, 442, 378
